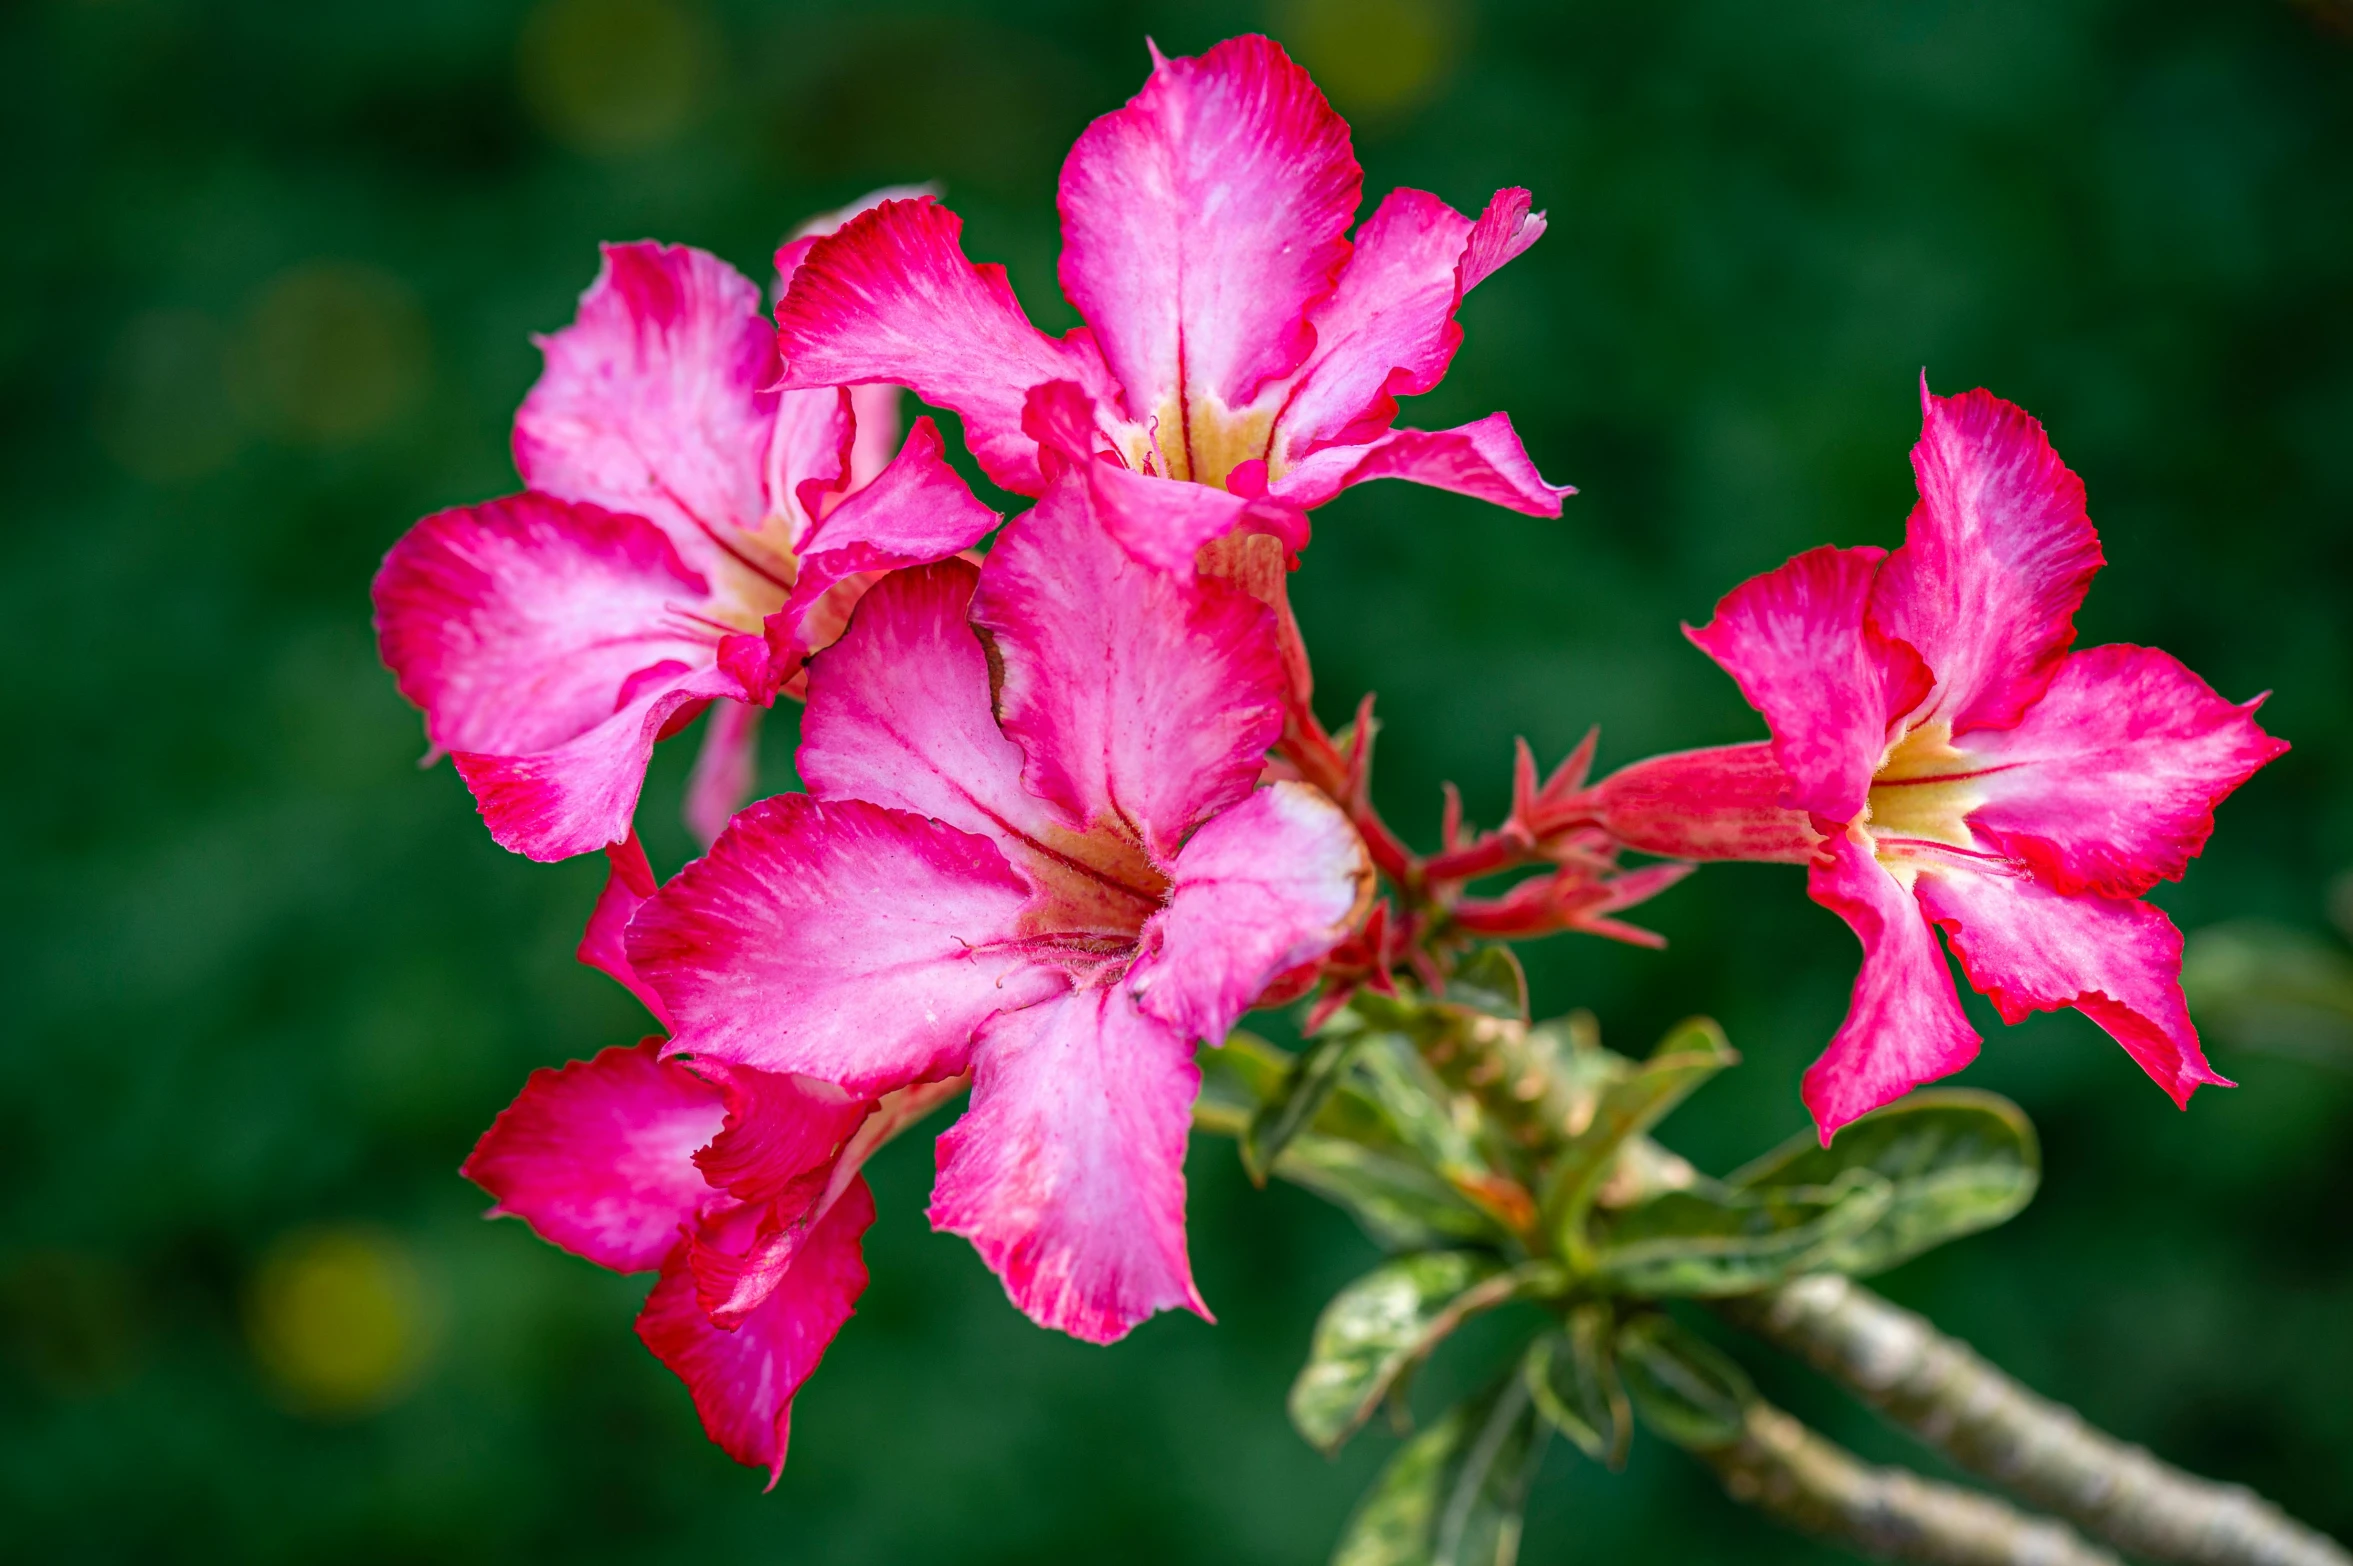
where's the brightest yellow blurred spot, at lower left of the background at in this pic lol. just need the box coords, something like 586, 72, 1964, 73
247, 1225, 431, 1418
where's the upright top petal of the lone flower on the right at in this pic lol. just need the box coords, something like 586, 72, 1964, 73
1871, 379, 2101, 734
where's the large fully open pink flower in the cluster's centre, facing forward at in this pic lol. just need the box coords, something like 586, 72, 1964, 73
628, 470, 1372, 1343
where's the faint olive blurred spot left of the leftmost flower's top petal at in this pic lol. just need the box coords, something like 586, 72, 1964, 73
228, 261, 431, 444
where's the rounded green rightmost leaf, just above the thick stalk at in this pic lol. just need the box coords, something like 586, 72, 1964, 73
1729, 1089, 2042, 1277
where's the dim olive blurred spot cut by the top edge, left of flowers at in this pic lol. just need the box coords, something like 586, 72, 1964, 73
518, 0, 718, 155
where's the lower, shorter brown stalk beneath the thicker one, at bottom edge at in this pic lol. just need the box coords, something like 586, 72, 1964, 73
1694, 1401, 2122, 1566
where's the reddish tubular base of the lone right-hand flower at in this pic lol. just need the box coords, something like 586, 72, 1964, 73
1593, 743, 1821, 865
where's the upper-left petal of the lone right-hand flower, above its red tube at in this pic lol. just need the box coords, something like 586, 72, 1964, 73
1685, 546, 1929, 823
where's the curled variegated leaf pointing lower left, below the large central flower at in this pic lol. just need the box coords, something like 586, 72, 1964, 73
1289, 1251, 1558, 1455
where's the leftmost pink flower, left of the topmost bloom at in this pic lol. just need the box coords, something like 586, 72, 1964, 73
374, 215, 995, 858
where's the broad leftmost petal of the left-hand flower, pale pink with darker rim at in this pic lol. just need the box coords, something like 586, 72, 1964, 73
374, 494, 718, 757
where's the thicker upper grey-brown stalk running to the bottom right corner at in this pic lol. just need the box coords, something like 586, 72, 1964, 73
1720, 1274, 2353, 1566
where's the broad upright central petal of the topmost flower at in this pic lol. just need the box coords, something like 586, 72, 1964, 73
1061, 38, 1365, 434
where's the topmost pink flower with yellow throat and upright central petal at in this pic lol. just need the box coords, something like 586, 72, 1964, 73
776, 38, 1569, 543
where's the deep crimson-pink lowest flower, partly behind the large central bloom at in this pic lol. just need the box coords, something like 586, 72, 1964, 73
464, 1039, 953, 1486
